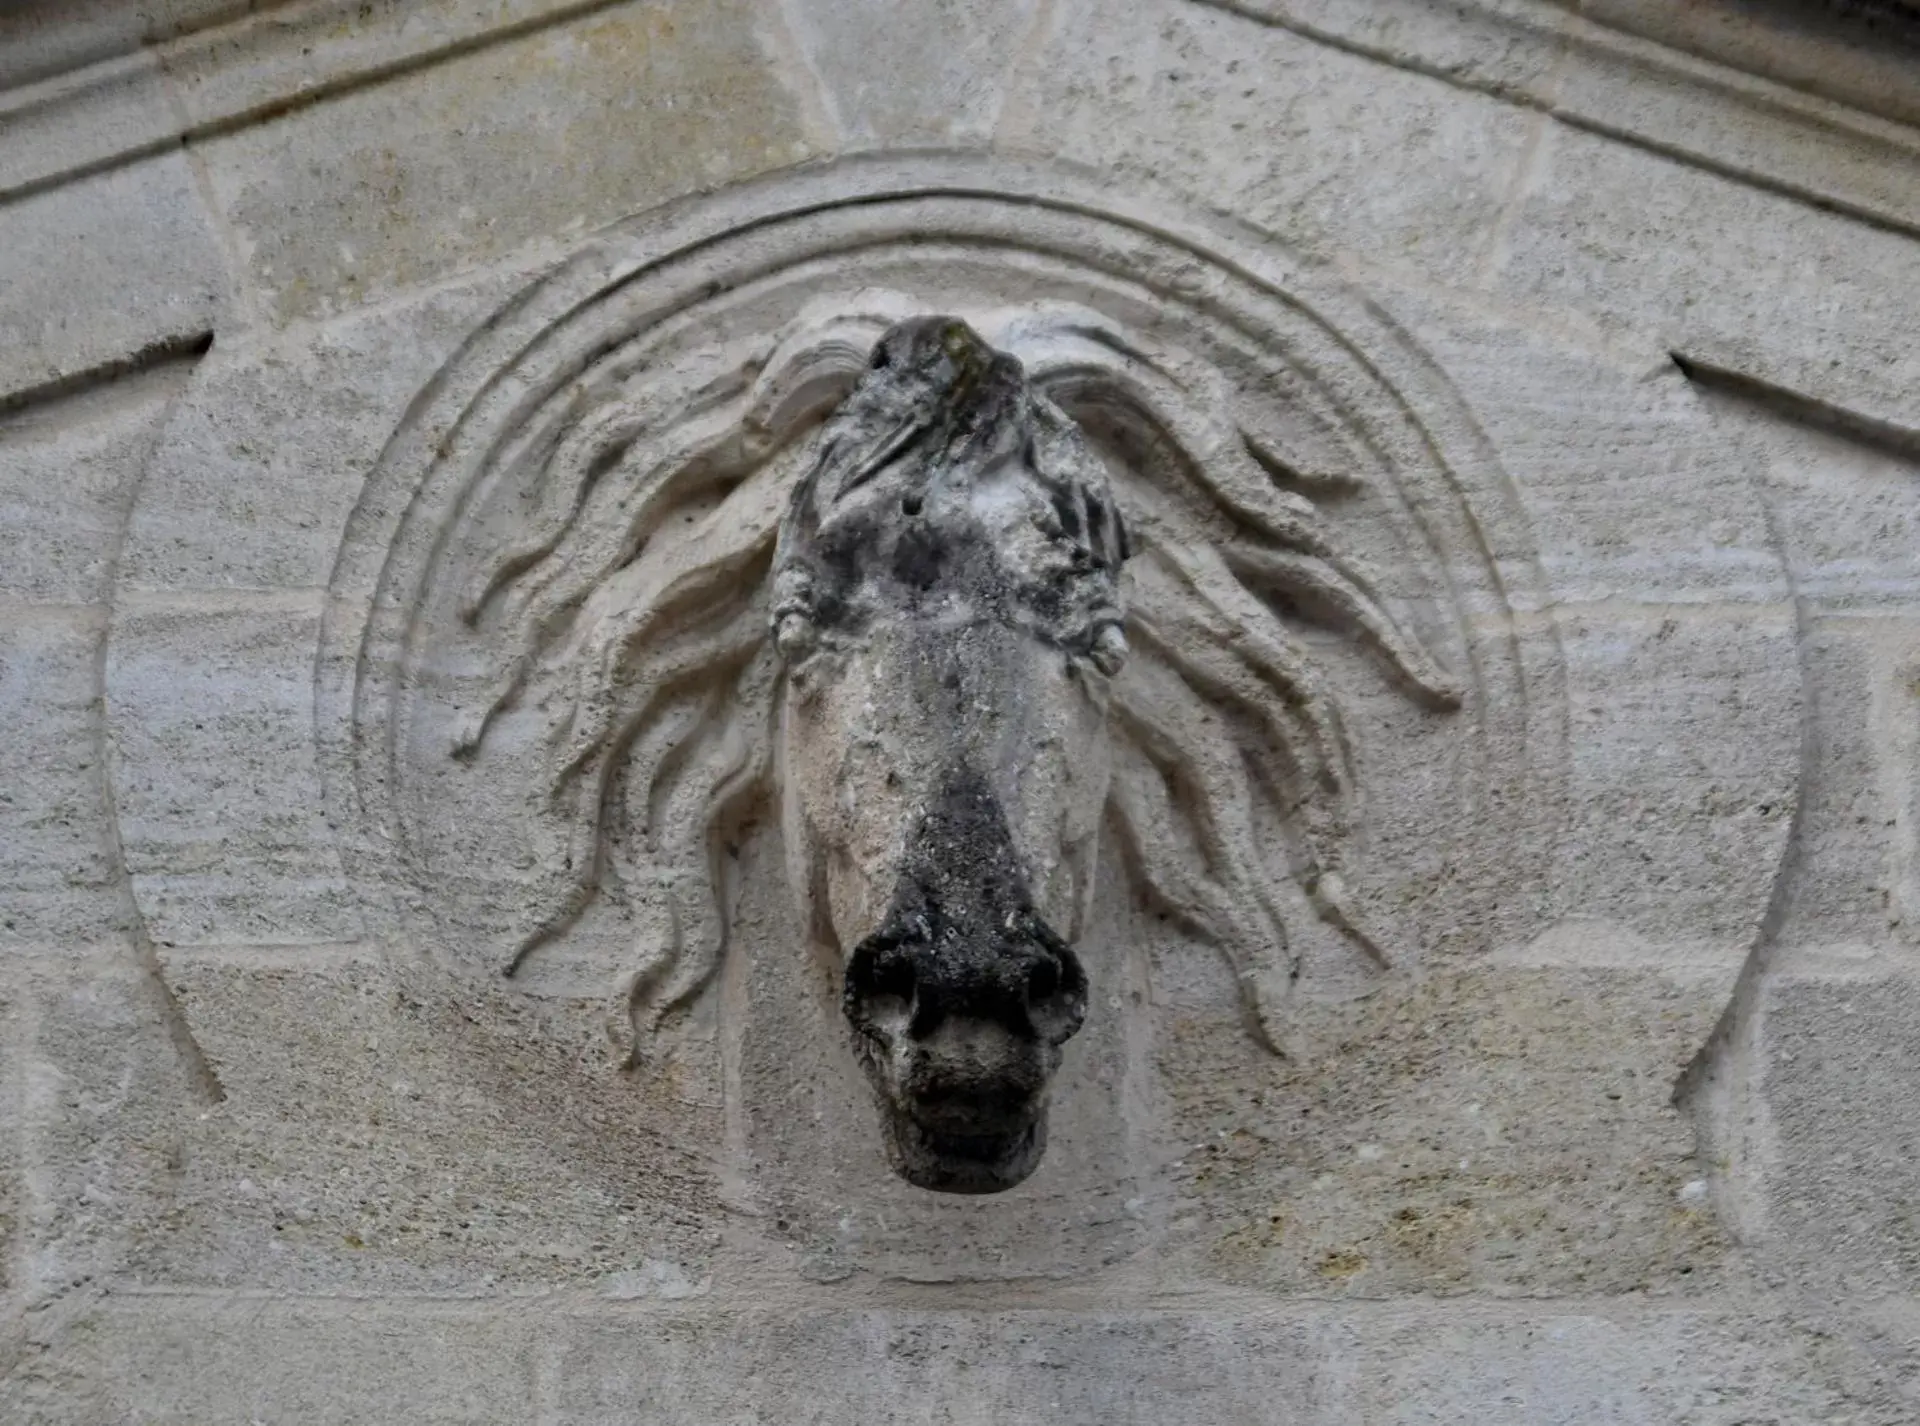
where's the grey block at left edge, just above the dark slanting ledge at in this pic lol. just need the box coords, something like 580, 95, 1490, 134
0, 154, 227, 393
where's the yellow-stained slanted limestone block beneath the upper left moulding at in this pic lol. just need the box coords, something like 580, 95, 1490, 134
182, 4, 818, 321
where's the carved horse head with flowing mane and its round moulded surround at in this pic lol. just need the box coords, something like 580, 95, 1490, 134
323, 150, 1561, 1235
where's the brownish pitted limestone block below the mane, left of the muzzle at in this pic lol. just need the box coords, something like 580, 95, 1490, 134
144, 946, 720, 1295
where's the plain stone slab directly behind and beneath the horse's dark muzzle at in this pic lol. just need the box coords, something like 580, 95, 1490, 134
737, 840, 1152, 1282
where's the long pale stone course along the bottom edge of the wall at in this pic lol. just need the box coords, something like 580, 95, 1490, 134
7, 1295, 1897, 1426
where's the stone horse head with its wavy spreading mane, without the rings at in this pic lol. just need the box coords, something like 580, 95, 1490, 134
455, 294, 1457, 1192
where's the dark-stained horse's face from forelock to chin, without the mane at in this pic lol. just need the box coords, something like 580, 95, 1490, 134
772, 317, 1127, 1192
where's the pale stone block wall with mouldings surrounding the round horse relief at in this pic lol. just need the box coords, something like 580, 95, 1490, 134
0, 0, 1920, 1426
